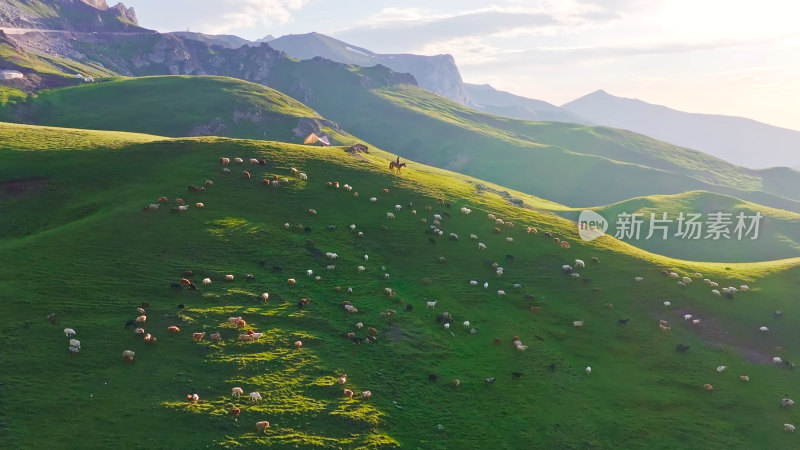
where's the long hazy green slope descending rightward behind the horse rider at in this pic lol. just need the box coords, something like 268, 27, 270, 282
268, 74, 800, 211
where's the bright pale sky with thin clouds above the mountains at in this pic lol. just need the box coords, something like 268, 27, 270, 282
125, 0, 800, 130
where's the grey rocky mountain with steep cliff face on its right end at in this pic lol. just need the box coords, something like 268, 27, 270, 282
269, 33, 467, 105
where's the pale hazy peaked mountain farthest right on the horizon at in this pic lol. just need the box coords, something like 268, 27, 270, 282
561, 90, 800, 169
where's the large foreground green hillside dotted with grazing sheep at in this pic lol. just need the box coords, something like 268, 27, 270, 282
0, 124, 800, 448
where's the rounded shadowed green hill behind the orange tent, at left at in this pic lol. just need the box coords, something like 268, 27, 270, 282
0, 77, 340, 141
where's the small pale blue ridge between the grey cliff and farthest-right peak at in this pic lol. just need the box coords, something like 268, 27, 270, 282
464, 83, 591, 125
